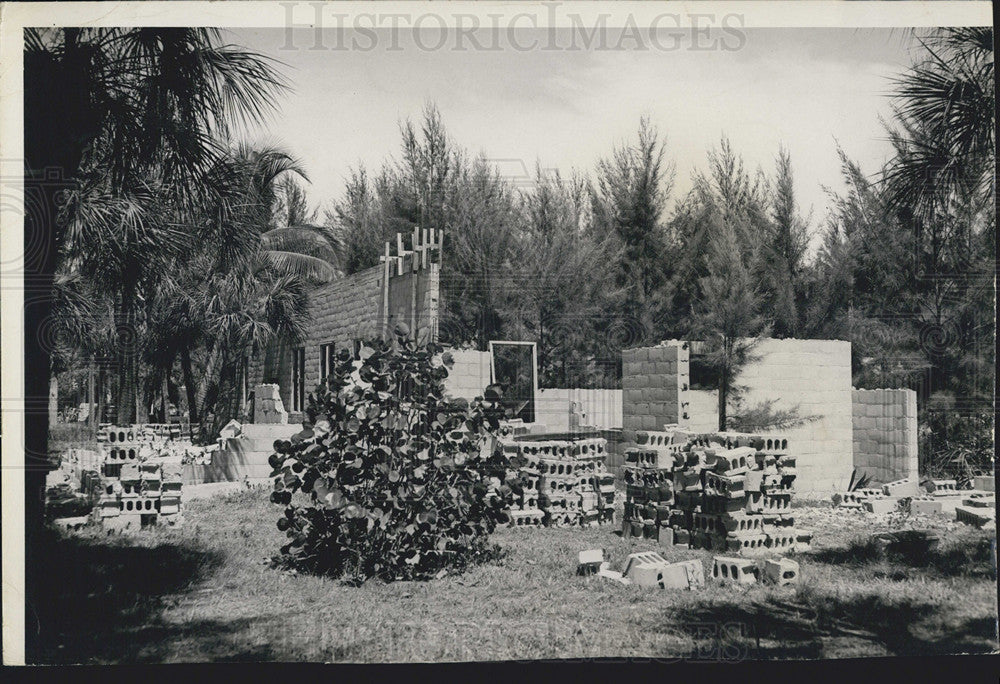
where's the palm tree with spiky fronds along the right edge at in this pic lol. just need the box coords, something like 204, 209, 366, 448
882, 27, 996, 400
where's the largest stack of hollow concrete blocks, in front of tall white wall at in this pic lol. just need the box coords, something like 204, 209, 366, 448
622, 430, 812, 555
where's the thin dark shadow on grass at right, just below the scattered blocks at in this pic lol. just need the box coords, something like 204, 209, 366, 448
803, 537, 996, 579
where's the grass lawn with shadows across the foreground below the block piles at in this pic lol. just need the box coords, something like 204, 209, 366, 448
35, 489, 997, 663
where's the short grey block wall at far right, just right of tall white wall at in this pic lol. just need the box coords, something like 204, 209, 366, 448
852, 389, 919, 483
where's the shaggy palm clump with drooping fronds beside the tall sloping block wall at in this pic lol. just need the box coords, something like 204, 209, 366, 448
146, 146, 341, 432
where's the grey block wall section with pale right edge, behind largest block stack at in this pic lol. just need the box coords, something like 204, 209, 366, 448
622, 340, 690, 432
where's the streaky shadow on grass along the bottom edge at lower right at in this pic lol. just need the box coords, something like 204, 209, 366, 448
651, 593, 997, 661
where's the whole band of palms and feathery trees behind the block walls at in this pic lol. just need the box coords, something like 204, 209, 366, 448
33, 29, 995, 468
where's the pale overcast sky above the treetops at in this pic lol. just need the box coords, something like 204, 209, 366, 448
226, 29, 919, 248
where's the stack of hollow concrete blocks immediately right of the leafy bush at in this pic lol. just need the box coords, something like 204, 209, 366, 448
503, 438, 615, 527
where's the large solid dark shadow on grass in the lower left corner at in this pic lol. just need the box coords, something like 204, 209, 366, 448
26, 532, 271, 664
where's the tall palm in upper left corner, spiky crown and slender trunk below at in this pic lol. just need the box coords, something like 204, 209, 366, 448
24, 28, 285, 430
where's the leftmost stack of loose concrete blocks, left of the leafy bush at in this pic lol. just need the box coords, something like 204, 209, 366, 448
94, 425, 183, 531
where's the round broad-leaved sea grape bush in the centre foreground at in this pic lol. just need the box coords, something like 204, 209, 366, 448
270, 335, 520, 583
